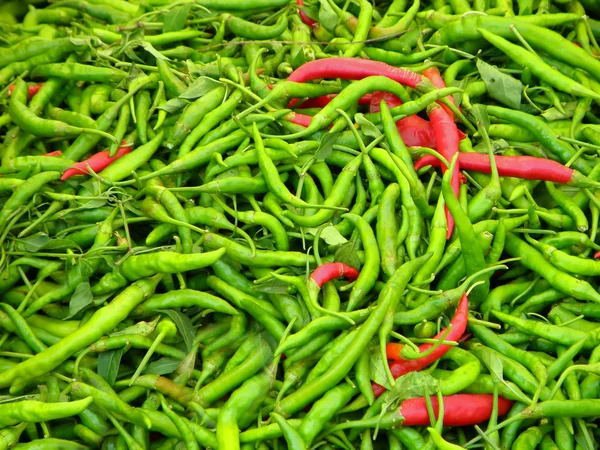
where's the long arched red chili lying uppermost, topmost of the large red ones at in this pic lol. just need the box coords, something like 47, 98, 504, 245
287, 58, 424, 88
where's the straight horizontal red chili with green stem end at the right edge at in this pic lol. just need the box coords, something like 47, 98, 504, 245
415, 153, 582, 185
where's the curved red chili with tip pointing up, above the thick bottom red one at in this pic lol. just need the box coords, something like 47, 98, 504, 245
371, 294, 469, 397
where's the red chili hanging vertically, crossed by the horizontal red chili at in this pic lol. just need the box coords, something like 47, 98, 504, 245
428, 104, 460, 239
